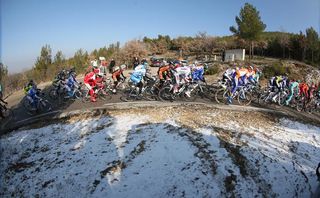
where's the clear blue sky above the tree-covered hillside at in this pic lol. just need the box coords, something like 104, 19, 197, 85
0, 0, 320, 73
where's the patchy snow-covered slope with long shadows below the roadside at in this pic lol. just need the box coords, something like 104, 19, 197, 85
0, 110, 320, 197
